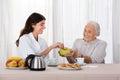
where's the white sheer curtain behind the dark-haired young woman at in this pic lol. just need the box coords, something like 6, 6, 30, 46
0, 0, 53, 60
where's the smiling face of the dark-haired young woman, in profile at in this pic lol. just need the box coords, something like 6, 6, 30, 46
32, 20, 46, 34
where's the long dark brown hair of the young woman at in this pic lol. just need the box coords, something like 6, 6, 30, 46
16, 13, 46, 46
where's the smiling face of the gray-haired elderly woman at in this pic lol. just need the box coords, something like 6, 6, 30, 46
83, 24, 96, 42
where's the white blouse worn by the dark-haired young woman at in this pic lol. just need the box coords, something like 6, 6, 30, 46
18, 33, 48, 58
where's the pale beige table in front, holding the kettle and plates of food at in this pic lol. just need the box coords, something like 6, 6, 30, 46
0, 64, 120, 80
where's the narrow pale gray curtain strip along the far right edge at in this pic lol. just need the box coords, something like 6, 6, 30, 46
112, 0, 120, 63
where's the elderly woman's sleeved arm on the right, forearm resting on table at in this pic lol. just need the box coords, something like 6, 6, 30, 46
75, 41, 107, 63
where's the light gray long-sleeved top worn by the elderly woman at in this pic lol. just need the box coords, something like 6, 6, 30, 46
73, 39, 107, 63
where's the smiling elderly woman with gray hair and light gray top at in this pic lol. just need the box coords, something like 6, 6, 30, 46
65, 21, 107, 63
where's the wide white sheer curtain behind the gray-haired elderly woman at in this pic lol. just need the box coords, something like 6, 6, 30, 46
53, 0, 113, 63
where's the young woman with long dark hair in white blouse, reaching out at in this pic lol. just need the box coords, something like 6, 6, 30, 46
16, 13, 64, 58
